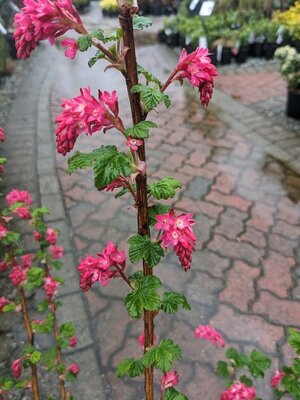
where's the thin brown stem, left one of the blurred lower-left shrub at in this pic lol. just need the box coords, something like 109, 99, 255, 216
8, 245, 40, 400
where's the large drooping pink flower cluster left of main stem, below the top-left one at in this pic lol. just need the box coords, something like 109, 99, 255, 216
55, 88, 123, 155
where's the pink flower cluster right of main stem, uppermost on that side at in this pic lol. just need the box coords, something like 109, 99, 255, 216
175, 47, 217, 106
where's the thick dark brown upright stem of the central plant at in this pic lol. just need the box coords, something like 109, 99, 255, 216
119, 5, 154, 400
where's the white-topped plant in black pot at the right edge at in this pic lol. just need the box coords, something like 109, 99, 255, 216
275, 46, 300, 119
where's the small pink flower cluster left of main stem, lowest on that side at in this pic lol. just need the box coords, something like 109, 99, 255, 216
78, 242, 126, 292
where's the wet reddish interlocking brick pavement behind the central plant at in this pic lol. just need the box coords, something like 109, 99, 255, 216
0, 5, 300, 400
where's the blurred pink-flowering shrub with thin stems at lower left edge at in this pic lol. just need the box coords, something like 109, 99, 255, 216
0, 128, 79, 400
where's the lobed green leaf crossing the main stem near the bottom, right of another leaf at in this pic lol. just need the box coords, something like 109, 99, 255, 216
142, 339, 182, 373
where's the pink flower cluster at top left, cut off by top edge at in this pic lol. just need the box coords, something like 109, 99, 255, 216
14, 0, 86, 59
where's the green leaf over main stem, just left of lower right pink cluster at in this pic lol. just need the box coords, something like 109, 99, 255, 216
127, 235, 164, 267
